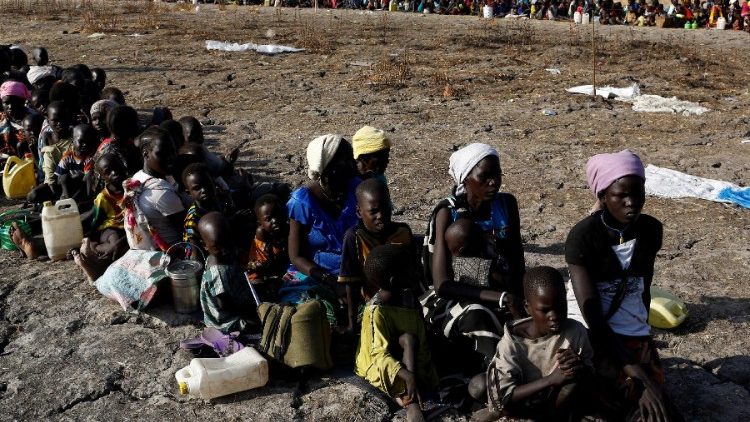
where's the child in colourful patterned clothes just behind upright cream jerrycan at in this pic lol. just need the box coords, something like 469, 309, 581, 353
55, 124, 99, 204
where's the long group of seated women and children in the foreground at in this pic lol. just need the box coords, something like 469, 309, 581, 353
0, 46, 679, 421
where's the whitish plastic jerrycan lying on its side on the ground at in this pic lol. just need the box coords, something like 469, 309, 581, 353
174, 347, 268, 400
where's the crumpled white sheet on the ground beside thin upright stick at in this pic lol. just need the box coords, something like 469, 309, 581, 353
567, 84, 711, 116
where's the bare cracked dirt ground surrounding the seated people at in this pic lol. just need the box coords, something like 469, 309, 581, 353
0, 1, 750, 421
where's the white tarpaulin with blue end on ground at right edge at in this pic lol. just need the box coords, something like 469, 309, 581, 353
646, 164, 750, 208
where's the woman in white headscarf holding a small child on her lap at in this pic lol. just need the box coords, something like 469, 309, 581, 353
421, 143, 524, 398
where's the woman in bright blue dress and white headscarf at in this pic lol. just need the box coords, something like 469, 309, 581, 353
279, 134, 359, 316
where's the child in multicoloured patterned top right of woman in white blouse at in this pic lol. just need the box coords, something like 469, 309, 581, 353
182, 163, 224, 259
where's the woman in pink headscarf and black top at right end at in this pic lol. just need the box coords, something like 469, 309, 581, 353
565, 150, 675, 421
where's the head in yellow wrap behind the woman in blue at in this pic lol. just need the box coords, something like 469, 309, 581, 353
352, 126, 391, 186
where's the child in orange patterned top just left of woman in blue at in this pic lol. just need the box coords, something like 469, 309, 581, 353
247, 194, 289, 281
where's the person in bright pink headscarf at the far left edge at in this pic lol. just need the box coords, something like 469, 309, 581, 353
0, 81, 33, 155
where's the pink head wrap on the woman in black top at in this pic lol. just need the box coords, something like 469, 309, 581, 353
586, 149, 646, 198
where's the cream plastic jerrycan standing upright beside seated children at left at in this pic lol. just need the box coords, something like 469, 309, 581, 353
42, 199, 83, 261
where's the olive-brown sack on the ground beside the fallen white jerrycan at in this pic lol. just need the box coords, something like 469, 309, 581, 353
258, 300, 333, 370
